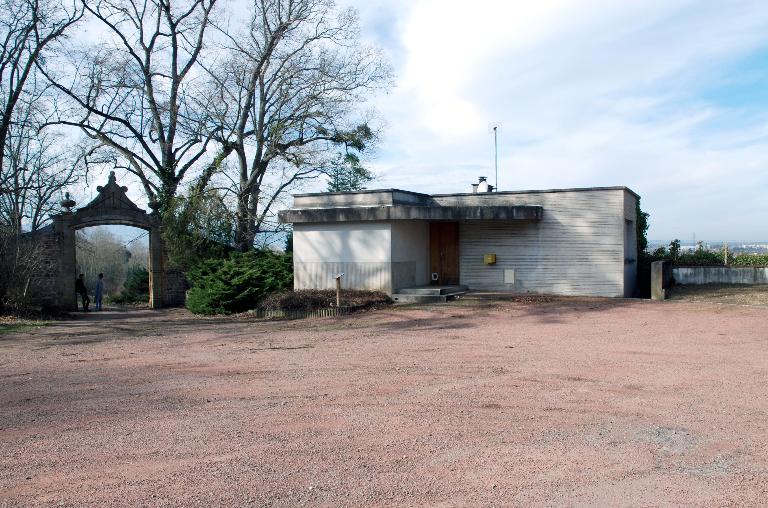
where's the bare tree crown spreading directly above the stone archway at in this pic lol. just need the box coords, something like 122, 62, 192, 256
40, 0, 216, 207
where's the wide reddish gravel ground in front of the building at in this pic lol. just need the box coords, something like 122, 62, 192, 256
0, 299, 768, 506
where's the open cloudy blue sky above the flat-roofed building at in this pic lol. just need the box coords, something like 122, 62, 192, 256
339, 0, 768, 241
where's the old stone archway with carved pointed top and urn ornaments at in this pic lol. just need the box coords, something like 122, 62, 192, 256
47, 171, 178, 310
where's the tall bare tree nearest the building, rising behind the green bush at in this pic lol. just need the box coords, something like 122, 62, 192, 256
202, 0, 391, 250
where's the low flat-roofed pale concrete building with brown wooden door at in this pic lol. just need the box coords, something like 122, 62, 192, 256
280, 180, 638, 299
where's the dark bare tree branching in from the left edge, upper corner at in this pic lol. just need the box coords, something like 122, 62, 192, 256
0, 0, 83, 178
